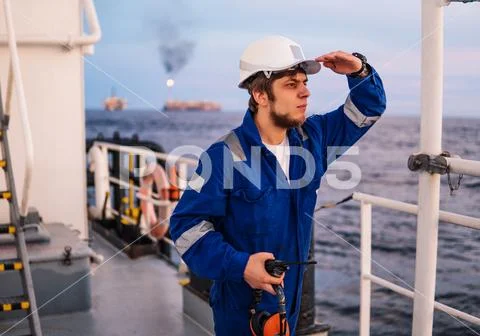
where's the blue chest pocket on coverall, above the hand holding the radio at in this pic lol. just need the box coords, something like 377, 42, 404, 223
231, 187, 272, 235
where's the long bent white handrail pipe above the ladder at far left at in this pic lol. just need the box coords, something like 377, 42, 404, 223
3, 0, 33, 217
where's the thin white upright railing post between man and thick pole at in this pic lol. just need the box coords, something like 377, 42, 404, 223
360, 201, 372, 336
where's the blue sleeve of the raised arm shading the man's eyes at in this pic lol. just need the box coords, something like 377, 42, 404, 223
304, 68, 386, 169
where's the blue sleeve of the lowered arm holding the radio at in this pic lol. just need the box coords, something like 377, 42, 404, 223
170, 144, 249, 281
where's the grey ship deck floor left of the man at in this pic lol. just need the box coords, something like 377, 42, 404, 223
0, 233, 211, 336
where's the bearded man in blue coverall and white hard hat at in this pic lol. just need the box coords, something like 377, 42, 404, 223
170, 36, 385, 336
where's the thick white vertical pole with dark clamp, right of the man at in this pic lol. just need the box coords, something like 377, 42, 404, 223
412, 0, 443, 336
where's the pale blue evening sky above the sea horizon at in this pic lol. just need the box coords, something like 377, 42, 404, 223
85, 0, 480, 117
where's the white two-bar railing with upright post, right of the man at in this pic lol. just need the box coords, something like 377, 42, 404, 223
353, 193, 480, 336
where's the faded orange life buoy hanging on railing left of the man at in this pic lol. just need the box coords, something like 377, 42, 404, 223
138, 164, 170, 239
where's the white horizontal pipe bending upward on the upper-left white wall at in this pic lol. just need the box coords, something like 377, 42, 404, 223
0, 0, 102, 48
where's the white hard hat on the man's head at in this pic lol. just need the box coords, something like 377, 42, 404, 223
238, 35, 321, 88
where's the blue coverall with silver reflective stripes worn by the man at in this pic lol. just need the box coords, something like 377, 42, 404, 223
170, 68, 386, 336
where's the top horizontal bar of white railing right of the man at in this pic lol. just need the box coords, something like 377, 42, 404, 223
353, 192, 480, 230
